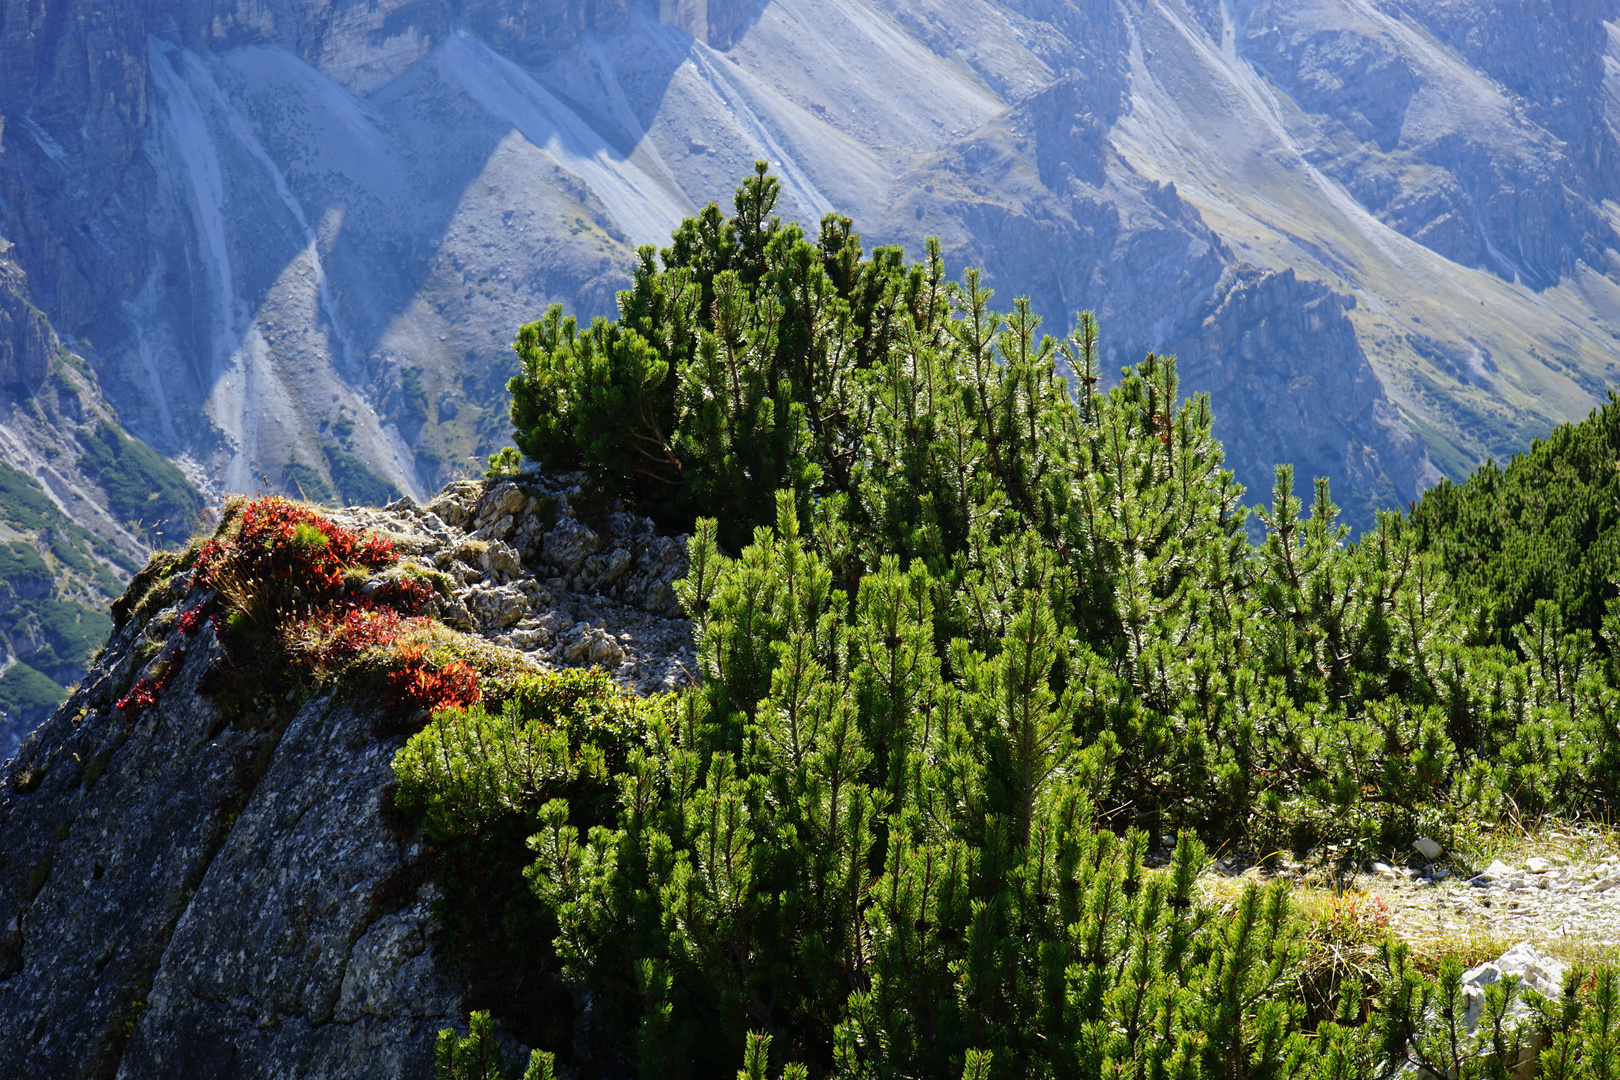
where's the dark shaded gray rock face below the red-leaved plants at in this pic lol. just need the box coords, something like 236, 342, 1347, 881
0, 625, 462, 1080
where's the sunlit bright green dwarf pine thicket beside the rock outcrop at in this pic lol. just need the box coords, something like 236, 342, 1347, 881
405, 165, 1620, 1080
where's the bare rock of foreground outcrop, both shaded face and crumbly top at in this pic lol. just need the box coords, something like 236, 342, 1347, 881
0, 479, 692, 1080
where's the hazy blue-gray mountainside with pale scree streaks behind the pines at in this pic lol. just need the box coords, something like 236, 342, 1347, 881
0, 0, 1620, 540
